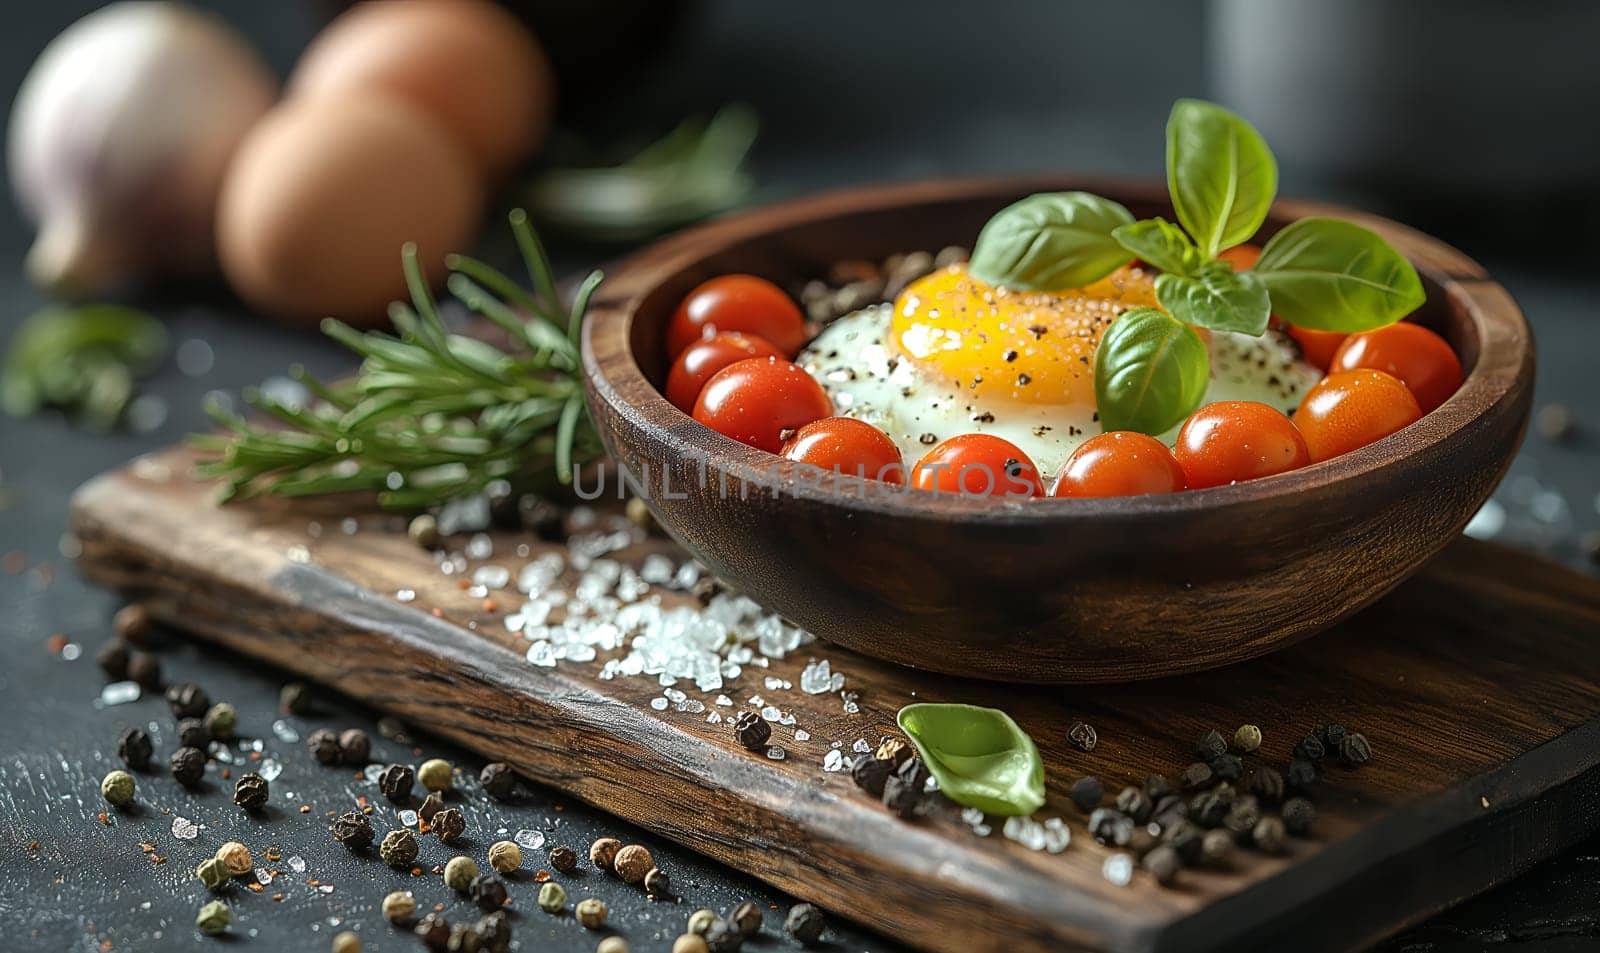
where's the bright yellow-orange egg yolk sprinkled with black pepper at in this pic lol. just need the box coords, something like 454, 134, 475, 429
890, 265, 1155, 406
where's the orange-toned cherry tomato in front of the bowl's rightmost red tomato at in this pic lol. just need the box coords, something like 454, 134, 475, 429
1294, 368, 1422, 462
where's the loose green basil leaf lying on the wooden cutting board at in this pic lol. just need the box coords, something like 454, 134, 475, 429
896, 704, 1045, 815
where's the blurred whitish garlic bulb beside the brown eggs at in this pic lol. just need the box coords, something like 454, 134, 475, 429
10, 0, 277, 294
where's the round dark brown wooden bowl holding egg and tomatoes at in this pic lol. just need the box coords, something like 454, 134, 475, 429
582, 176, 1533, 683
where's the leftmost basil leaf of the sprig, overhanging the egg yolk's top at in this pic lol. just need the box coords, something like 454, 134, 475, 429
968, 192, 1133, 291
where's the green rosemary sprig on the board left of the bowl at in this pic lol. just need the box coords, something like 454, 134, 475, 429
190, 209, 602, 510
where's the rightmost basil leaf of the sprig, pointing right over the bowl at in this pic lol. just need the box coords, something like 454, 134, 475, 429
1253, 219, 1427, 333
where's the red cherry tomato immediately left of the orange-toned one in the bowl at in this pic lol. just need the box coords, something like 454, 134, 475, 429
1173, 400, 1310, 489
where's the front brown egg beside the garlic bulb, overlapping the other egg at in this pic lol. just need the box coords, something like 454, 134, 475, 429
218, 96, 485, 325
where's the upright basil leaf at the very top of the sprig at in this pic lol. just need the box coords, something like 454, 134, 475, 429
1166, 99, 1278, 257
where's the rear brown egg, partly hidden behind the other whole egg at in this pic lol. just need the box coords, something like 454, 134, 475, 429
290, 0, 555, 176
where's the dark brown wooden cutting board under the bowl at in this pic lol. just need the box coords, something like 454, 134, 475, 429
74, 449, 1600, 953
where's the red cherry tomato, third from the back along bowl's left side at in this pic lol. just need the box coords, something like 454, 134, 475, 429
694, 357, 834, 453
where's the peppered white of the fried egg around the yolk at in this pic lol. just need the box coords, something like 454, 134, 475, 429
795, 304, 1322, 481
